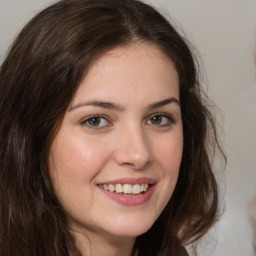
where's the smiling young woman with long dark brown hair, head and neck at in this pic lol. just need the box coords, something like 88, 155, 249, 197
0, 0, 224, 256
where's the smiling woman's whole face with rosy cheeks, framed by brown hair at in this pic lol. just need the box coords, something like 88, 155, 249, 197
50, 43, 183, 241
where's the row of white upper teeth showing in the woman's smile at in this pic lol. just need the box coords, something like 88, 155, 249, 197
101, 184, 149, 195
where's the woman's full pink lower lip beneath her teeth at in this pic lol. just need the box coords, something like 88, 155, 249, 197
99, 185, 155, 205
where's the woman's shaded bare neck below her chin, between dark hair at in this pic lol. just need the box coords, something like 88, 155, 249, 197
73, 229, 136, 256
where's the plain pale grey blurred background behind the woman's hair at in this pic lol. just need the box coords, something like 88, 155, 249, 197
0, 0, 256, 256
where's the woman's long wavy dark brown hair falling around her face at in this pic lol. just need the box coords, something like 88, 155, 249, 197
0, 0, 224, 256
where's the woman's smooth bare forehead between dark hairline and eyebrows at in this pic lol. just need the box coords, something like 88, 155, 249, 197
72, 43, 179, 104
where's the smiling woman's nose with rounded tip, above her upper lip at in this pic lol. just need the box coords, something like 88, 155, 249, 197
114, 124, 152, 170
